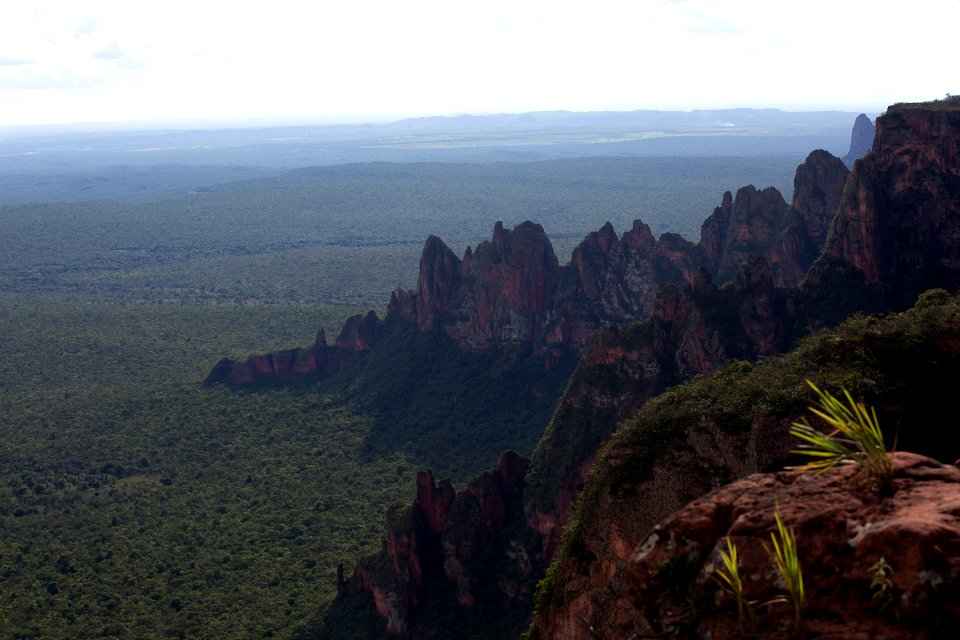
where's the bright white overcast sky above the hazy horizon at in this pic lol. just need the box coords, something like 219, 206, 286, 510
0, 0, 960, 126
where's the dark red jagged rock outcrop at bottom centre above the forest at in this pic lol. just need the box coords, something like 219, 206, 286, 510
330, 451, 531, 638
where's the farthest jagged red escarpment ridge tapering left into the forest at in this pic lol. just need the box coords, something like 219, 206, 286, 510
203, 150, 846, 386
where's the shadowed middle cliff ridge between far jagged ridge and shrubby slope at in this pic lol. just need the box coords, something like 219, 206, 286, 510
524, 256, 795, 563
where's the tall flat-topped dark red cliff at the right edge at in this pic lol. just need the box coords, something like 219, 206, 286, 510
810, 103, 960, 308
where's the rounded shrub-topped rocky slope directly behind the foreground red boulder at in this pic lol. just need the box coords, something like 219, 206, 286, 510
536, 292, 960, 640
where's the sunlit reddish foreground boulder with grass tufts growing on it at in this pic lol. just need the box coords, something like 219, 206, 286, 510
632, 453, 960, 640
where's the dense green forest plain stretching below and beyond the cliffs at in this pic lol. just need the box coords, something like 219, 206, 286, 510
0, 156, 802, 638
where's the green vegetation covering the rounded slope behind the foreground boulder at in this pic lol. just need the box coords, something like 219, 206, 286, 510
533, 290, 960, 637
